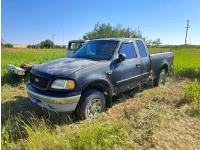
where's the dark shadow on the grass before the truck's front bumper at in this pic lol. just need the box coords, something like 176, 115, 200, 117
1, 96, 76, 127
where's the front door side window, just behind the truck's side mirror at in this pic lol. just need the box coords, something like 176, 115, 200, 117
119, 43, 137, 59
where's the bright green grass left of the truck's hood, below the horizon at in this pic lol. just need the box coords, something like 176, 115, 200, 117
1, 48, 66, 84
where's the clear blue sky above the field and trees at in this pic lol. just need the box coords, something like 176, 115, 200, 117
1, 0, 200, 44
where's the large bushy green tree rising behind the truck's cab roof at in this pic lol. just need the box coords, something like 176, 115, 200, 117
83, 23, 142, 40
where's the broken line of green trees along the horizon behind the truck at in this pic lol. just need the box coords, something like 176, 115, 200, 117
1, 23, 161, 49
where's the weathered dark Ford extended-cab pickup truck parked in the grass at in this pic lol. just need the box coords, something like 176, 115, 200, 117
27, 38, 173, 119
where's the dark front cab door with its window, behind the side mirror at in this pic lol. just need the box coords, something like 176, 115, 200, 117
116, 42, 141, 92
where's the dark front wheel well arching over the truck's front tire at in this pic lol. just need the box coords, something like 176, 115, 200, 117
82, 81, 112, 107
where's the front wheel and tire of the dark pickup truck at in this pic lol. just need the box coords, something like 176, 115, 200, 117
77, 89, 106, 120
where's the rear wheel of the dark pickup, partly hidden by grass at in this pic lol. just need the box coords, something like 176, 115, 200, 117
153, 69, 167, 86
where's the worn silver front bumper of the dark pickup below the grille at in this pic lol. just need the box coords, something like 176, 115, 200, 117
27, 83, 81, 112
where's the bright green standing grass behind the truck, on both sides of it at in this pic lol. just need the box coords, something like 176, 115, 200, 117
1, 46, 200, 84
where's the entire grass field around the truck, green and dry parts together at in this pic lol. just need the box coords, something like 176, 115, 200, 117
1, 46, 200, 149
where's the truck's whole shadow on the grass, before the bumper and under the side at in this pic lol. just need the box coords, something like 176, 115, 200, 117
1, 82, 152, 127
